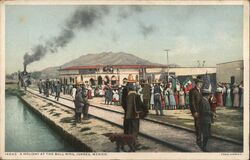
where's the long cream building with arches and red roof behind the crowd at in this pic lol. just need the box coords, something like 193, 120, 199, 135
59, 65, 216, 85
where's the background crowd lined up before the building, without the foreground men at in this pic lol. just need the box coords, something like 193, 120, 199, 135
38, 75, 243, 122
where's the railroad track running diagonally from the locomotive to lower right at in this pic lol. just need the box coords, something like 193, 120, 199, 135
27, 88, 243, 152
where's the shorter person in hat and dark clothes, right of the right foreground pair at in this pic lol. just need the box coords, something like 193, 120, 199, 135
198, 89, 213, 152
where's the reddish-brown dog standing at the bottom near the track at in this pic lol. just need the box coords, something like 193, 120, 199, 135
104, 133, 136, 152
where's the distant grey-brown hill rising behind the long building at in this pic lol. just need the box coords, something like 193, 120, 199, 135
38, 52, 178, 79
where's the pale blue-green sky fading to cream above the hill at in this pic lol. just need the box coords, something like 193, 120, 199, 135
5, 5, 243, 74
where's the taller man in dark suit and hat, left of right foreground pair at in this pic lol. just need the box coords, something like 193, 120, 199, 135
189, 76, 203, 146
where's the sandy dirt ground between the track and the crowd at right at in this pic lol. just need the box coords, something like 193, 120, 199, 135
149, 107, 243, 141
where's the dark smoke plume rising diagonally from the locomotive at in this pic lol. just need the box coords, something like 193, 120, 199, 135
23, 6, 109, 66
